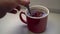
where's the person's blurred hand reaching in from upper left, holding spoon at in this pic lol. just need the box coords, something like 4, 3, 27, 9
0, 0, 30, 18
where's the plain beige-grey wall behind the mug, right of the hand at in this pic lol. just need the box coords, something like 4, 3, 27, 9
31, 0, 60, 9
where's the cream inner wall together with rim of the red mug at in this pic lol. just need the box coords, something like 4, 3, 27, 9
26, 5, 49, 19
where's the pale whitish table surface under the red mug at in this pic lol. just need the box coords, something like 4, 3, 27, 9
0, 9, 60, 34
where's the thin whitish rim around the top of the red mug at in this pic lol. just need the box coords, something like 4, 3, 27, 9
25, 5, 49, 19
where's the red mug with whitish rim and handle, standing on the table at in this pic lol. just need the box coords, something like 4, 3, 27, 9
20, 5, 49, 33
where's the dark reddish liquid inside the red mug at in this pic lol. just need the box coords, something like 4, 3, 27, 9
28, 8, 46, 17
